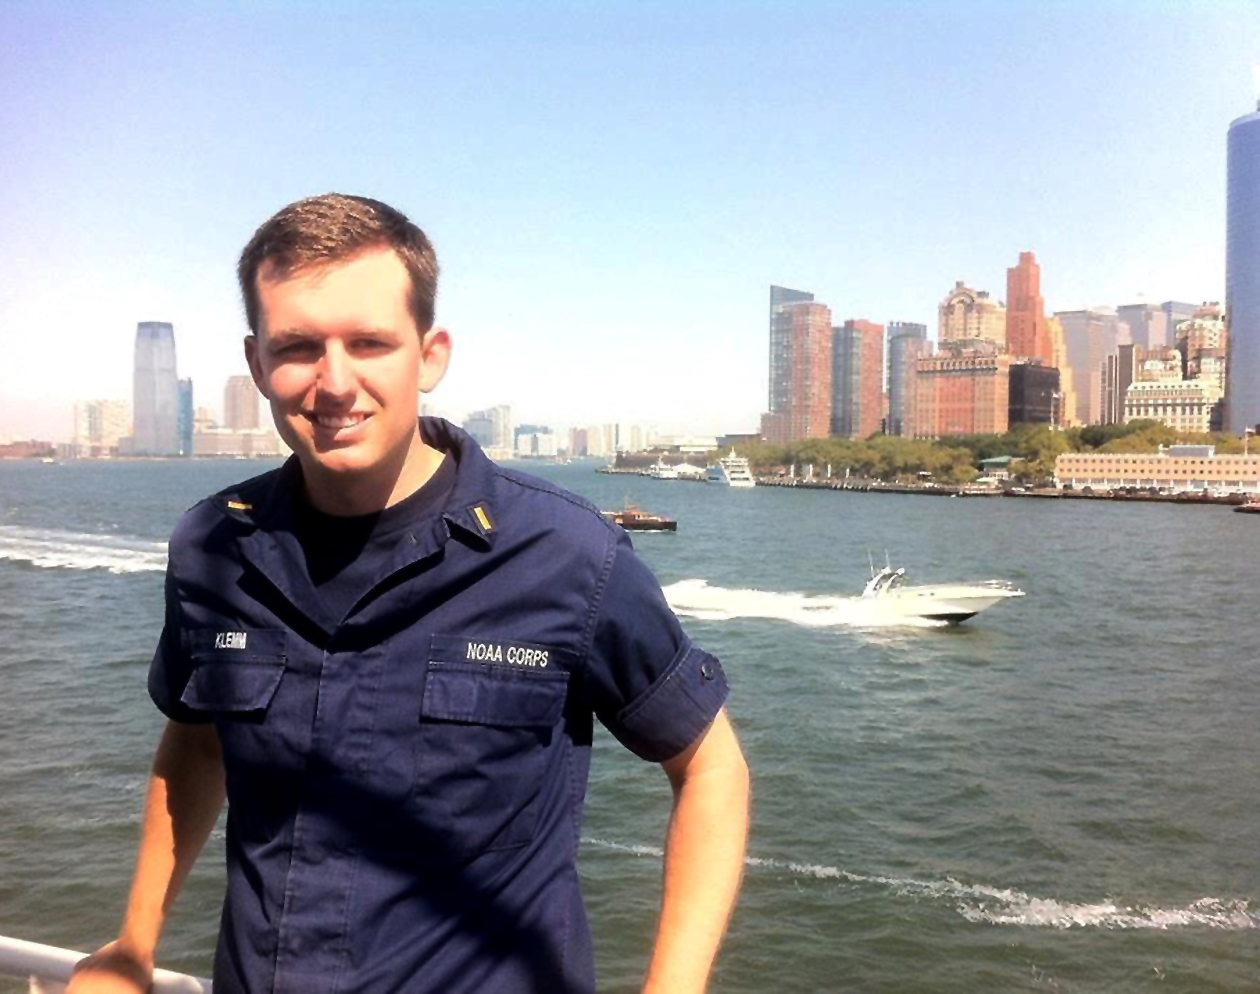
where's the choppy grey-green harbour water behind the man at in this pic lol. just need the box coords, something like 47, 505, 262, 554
0, 461, 1260, 994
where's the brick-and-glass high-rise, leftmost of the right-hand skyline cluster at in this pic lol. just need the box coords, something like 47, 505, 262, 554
761, 286, 832, 443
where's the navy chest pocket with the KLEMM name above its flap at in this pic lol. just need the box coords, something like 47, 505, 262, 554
180, 629, 287, 768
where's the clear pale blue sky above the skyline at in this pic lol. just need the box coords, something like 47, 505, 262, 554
0, 0, 1260, 438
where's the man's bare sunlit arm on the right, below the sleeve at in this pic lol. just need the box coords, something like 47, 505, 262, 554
643, 711, 748, 994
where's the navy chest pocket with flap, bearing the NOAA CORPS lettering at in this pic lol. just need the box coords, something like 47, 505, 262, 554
416, 636, 568, 857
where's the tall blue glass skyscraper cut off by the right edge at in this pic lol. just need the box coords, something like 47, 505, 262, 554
1225, 102, 1260, 435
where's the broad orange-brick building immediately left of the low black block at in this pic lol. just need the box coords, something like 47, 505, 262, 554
914, 343, 1012, 438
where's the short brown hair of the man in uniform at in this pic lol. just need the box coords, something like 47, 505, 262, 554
237, 193, 437, 335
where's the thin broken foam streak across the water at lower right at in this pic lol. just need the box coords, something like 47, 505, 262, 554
582, 838, 1260, 931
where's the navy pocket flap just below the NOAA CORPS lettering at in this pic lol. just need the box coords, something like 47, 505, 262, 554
420, 660, 568, 728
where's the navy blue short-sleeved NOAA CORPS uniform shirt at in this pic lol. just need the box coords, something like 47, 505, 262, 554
149, 418, 727, 994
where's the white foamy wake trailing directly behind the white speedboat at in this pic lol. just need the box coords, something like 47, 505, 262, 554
664, 580, 946, 629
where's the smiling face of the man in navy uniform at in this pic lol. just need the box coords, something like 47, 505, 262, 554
246, 248, 446, 486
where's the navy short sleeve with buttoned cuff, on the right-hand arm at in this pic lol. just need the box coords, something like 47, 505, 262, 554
586, 533, 728, 762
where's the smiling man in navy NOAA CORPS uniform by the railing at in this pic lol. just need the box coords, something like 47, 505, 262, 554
71, 194, 747, 994
